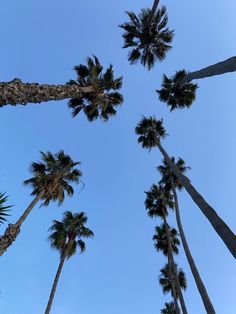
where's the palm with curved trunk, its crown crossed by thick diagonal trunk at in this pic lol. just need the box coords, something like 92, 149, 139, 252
157, 157, 216, 314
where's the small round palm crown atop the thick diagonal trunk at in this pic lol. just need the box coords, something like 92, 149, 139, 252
135, 117, 167, 149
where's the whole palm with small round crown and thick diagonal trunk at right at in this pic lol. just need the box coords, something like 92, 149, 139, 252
135, 117, 236, 258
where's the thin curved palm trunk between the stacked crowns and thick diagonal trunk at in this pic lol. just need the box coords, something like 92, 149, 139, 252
171, 178, 216, 314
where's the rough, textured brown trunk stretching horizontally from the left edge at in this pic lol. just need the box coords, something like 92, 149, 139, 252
0, 79, 93, 107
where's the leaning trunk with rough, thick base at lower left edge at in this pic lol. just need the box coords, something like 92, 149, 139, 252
0, 191, 44, 256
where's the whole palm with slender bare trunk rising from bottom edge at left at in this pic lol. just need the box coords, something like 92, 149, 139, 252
45, 211, 93, 314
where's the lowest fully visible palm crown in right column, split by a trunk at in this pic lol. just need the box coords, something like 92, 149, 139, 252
159, 264, 187, 294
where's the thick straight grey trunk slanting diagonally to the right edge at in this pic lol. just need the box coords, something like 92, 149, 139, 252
157, 141, 236, 258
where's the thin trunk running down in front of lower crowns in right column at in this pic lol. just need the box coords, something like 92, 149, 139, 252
164, 216, 188, 314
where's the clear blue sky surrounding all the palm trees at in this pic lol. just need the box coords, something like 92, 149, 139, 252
0, 0, 236, 314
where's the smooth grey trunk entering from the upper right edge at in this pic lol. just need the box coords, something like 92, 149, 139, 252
183, 56, 236, 83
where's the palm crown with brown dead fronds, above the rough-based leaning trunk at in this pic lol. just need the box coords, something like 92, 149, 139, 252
24, 150, 82, 206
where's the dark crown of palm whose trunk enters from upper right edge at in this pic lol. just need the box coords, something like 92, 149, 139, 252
157, 70, 197, 111
